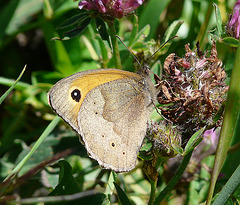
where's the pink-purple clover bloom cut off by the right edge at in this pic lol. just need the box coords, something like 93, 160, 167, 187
227, 0, 240, 39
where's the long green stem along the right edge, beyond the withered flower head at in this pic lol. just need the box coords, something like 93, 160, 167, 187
206, 35, 240, 205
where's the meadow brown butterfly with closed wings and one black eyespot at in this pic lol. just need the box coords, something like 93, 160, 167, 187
48, 69, 156, 172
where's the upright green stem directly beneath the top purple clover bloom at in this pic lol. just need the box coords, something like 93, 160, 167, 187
108, 21, 122, 69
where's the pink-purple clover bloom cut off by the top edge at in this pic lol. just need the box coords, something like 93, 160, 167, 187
78, 0, 144, 18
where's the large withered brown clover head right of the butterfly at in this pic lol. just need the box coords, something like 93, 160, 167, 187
158, 42, 228, 138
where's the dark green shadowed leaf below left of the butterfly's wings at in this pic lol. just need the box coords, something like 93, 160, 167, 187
49, 160, 80, 196
